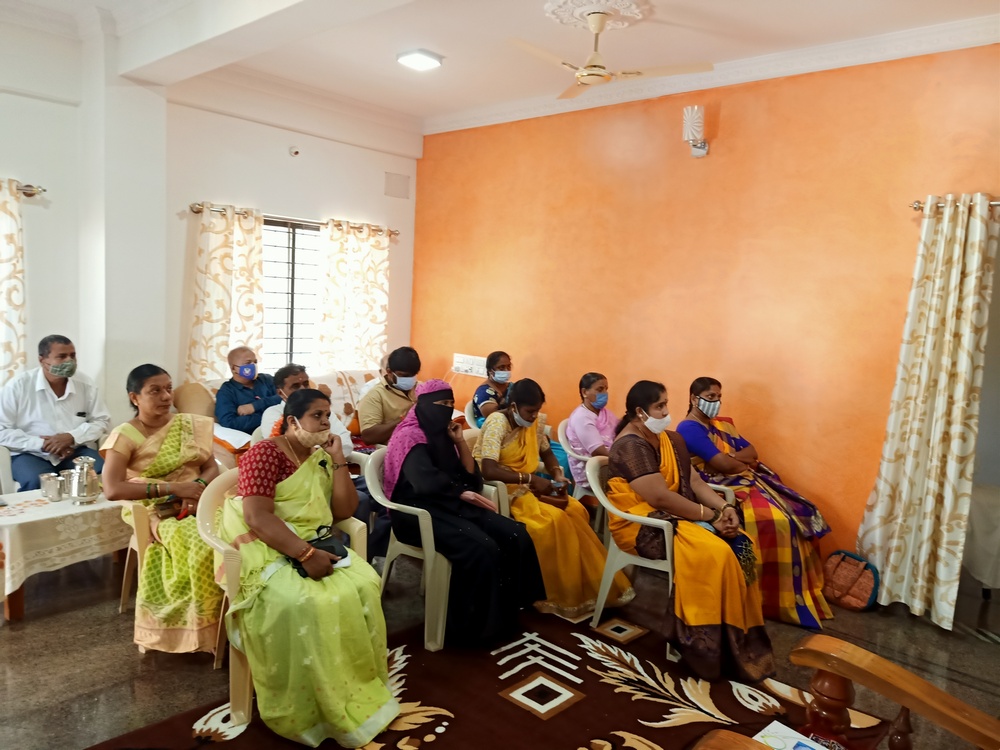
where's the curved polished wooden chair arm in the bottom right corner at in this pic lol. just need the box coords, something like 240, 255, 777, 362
788, 635, 1000, 749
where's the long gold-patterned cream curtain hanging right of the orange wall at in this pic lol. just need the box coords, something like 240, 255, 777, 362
858, 193, 1000, 630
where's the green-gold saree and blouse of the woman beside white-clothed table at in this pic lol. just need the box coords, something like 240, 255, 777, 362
101, 414, 222, 653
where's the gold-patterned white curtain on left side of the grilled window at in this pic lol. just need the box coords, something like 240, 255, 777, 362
185, 202, 264, 383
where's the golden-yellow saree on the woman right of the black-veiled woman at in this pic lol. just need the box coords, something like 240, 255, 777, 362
500, 420, 635, 617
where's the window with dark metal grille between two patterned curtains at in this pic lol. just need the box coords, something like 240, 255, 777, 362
258, 219, 320, 373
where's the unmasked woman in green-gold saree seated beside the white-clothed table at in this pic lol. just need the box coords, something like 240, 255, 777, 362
101, 365, 222, 653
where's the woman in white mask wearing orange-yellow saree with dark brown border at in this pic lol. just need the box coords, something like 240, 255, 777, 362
607, 380, 774, 682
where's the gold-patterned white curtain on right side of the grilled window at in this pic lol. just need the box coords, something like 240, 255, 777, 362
316, 221, 389, 372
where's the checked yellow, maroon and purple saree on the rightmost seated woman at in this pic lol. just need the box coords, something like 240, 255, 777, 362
692, 419, 833, 628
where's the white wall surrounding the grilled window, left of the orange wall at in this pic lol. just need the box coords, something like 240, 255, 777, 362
164, 104, 416, 379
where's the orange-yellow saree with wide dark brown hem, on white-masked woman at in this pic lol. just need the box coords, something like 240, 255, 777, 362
607, 432, 774, 682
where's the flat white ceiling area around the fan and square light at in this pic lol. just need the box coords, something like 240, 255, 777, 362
230, 0, 998, 118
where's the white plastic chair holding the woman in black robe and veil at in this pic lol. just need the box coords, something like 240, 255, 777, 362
365, 448, 451, 651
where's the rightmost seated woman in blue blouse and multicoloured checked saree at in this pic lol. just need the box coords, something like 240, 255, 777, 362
677, 377, 833, 628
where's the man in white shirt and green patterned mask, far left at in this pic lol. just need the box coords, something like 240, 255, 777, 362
0, 335, 111, 492
